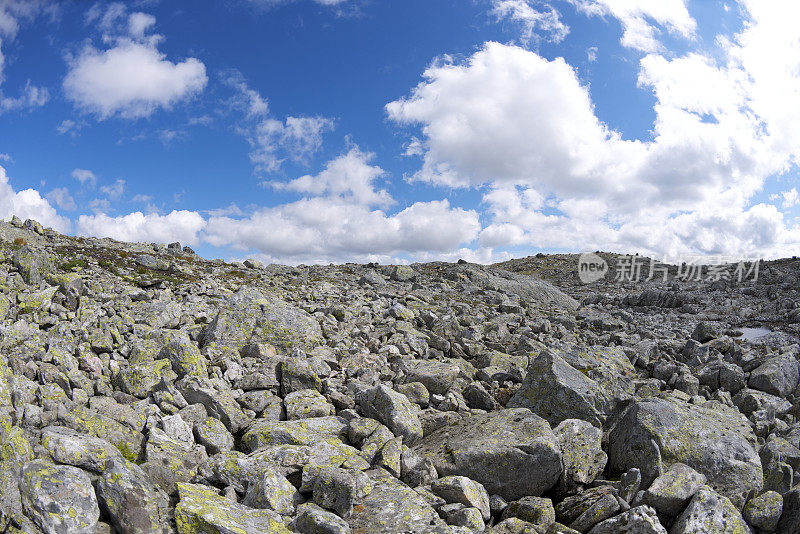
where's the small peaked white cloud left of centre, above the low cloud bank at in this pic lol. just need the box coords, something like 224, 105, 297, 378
269, 147, 394, 207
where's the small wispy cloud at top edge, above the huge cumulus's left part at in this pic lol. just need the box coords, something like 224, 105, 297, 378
492, 0, 569, 44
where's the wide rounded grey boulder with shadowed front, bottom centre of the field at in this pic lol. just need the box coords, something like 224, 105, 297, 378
413, 408, 562, 500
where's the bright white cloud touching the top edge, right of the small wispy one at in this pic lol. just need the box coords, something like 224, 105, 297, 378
567, 0, 697, 52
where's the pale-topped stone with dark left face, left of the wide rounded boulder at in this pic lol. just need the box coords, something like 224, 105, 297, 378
358, 385, 422, 446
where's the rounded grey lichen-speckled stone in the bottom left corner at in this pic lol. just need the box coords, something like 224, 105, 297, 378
19, 460, 100, 534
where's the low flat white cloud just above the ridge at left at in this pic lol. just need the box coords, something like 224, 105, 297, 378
77, 210, 206, 246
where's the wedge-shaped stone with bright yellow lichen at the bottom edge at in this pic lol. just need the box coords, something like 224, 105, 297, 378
175, 483, 291, 534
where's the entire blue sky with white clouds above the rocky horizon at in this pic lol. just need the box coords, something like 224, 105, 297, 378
0, 0, 800, 263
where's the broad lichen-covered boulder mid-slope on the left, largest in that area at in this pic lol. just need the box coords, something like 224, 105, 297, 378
202, 288, 322, 361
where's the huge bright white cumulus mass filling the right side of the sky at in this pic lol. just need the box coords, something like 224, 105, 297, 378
387, 1, 800, 264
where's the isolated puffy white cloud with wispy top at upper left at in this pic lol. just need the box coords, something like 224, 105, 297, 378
63, 4, 208, 119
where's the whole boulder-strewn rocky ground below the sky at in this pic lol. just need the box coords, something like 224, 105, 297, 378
0, 218, 800, 534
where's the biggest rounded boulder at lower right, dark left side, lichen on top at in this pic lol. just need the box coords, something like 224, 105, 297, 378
608, 396, 764, 508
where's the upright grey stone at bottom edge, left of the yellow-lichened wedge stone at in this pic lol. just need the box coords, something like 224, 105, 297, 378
97, 458, 166, 534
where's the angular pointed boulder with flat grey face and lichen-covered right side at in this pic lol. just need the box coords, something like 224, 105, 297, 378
507, 347, 634, 427
